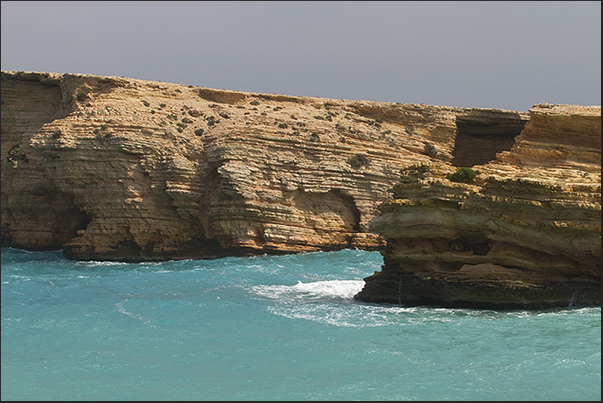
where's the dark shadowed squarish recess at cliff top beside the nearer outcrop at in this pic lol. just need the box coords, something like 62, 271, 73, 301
452, 111, 527, 167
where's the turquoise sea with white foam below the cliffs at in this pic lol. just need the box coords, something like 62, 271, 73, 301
1, 248, 601, 401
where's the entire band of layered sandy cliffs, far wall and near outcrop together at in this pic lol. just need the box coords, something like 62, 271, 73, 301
1, 71, 601, 307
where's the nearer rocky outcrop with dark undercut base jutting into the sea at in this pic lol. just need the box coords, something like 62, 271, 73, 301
356, 104, 601, 309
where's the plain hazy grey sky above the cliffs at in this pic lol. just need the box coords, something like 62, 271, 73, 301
0, 1, 601, 111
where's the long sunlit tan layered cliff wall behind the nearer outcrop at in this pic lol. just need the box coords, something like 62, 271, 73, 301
1, 71, 528, 261
